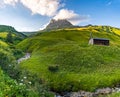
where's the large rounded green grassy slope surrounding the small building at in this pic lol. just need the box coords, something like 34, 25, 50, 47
17, 26, 120, 92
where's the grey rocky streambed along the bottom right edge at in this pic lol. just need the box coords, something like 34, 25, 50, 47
55, 87, 120, 97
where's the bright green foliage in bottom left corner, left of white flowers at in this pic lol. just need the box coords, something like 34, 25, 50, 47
0, 69, 22, 97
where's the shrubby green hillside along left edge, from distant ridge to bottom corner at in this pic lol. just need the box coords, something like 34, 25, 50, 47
0, 25, 39, 97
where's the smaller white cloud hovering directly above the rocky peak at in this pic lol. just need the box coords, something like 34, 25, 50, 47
54, 9, 89, 25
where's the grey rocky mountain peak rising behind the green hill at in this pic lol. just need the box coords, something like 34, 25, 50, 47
46, 19, 73, 30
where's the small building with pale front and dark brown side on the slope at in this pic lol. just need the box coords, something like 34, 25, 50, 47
89, 38, 109, 46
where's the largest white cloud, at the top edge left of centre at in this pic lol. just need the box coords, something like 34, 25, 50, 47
3, 0, 61, 16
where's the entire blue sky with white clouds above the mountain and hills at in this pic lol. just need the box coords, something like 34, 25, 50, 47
0, 0, 120, 31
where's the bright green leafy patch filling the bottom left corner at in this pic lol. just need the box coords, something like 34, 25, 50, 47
0, 69, 27, 97
